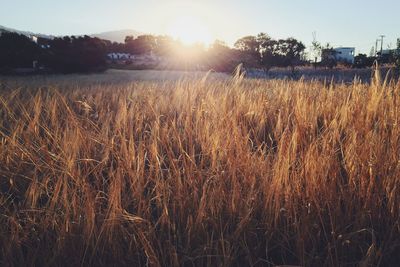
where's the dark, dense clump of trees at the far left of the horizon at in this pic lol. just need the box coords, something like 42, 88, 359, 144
0, 32, 107, 73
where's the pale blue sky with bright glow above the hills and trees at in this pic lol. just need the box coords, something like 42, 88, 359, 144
0, 0, 400, 53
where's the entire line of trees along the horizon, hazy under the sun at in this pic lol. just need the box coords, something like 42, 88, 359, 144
0, 32, 400, 73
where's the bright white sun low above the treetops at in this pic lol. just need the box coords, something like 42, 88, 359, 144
167, 16, 213, 45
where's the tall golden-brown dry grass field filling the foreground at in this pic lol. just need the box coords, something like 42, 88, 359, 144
0, 72, 400, 266
